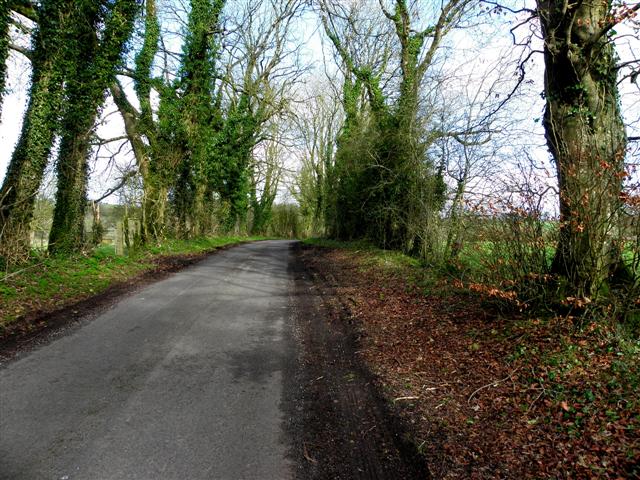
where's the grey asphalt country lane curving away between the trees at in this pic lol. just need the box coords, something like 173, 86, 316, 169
0, 241, 295, 480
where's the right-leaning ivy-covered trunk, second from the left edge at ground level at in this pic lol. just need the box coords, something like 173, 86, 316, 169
49, 0, 141, 253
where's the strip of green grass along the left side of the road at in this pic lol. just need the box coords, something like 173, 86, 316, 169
0, 237, 265, 334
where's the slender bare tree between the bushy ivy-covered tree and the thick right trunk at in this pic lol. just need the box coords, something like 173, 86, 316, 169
431, 55, 520, 262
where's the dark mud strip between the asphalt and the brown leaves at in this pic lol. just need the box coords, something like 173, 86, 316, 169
285, 244, 430, 480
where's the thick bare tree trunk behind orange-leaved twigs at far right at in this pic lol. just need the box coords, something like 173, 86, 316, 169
538, 0, 627, 297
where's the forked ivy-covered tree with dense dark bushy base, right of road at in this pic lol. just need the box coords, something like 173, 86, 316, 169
320, 0, 471, 253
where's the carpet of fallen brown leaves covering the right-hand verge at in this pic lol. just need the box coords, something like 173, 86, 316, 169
305, 249, 640, 479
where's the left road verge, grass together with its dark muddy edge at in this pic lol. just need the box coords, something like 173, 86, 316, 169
0, 237, 261, 362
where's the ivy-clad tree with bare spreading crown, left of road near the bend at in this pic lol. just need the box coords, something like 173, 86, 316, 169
212, 0, 304, 229
